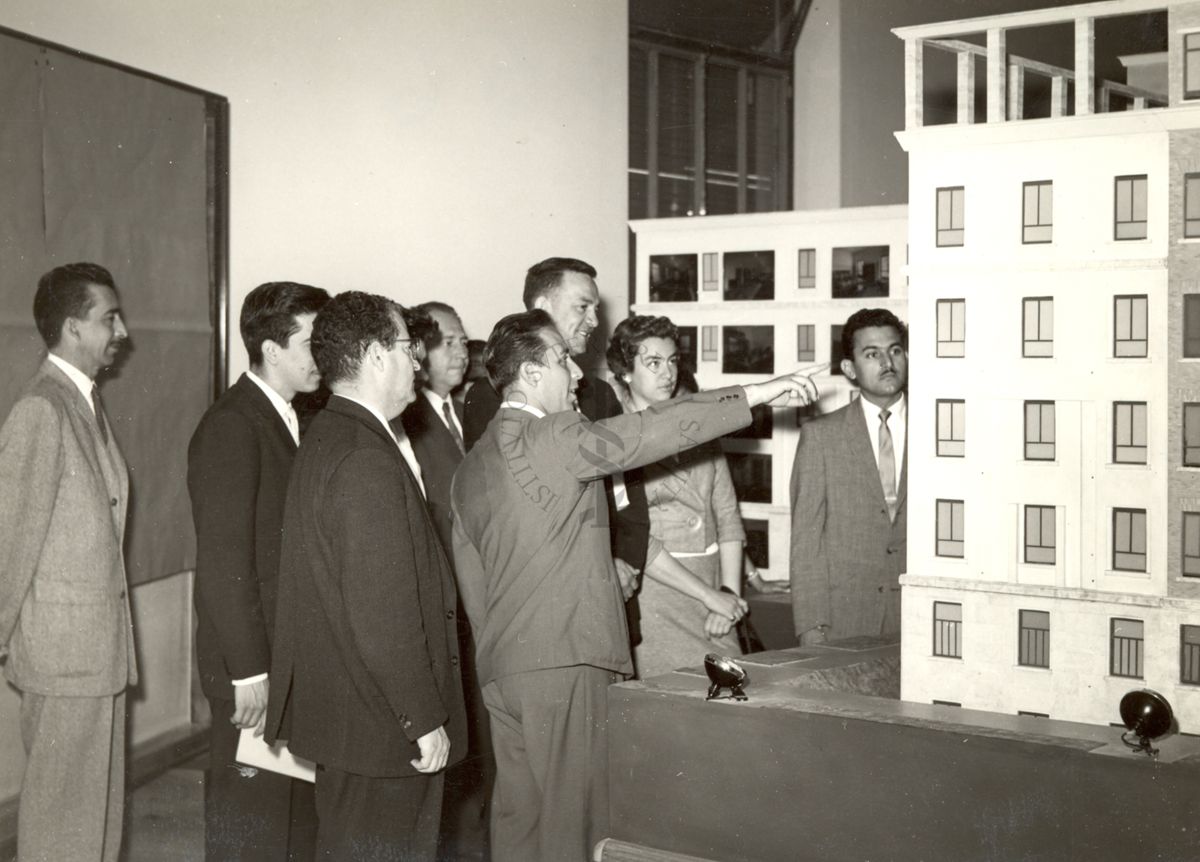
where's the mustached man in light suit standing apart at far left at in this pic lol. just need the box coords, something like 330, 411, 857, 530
0, 263, 137, 862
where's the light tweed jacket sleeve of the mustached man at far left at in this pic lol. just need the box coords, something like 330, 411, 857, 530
0, 397, 62, 657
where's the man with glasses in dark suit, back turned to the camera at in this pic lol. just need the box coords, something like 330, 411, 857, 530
266, 291, 466, 860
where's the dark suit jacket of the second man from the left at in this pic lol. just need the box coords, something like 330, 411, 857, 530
187, 375, 296, 700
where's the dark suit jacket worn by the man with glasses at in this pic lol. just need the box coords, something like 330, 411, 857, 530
266, 395, 467, 777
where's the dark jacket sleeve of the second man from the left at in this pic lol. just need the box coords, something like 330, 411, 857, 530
187, 411, 270, 680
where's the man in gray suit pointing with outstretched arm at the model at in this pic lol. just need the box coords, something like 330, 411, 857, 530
451, 309, 815, 862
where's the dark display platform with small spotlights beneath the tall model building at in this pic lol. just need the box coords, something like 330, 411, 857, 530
598, 646, 1200, 862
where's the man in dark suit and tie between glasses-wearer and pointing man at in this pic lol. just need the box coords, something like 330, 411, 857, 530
391, 301, 493, 855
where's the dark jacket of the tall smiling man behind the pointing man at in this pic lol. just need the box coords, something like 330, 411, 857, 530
462, 375, 661, 571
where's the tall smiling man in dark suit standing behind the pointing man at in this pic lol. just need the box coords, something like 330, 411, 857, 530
463, 257, 660, 607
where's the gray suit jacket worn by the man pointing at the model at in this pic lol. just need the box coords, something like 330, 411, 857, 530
451, 387, 750, 684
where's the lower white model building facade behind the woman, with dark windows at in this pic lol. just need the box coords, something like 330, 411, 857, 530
630, 206, 907, 588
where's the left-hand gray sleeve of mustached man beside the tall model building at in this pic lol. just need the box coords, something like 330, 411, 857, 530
790, 424, 830, 636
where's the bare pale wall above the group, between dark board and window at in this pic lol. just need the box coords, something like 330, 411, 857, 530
0, 0, 628, 376
